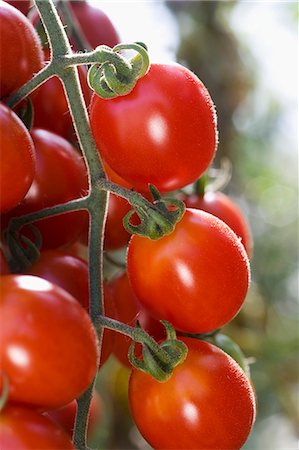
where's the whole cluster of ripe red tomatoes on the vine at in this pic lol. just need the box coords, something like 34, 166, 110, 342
0, 0, 255, 450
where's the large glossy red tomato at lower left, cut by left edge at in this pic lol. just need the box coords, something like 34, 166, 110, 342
0, 275, 98, 409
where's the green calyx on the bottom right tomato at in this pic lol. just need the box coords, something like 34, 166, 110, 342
128, 320, 188, 382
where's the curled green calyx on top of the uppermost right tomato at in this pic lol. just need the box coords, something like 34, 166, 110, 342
88, 43, 150, 99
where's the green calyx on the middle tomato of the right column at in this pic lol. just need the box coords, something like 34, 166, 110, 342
123, 185, 185, 240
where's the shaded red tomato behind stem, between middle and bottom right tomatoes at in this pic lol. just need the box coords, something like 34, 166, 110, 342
107, 272, 165, 369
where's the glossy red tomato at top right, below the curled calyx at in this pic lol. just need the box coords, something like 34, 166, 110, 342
90, 64, 217, 192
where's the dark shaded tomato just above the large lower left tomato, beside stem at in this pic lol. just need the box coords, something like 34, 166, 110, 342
24, 250, 89, 311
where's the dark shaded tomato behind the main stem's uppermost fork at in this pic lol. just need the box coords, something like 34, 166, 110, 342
31, 49, 91, 139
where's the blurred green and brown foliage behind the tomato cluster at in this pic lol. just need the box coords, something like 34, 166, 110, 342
89, 1, 299, 450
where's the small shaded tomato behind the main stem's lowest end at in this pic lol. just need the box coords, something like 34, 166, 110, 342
45, 391, 102, 437
